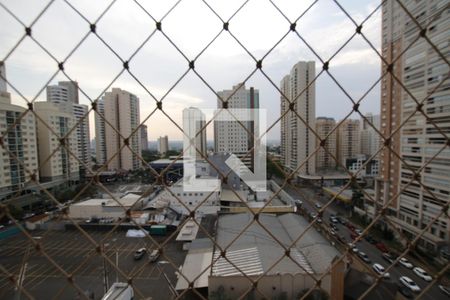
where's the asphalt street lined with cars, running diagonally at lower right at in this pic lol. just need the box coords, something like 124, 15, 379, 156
280, 182, 449, 300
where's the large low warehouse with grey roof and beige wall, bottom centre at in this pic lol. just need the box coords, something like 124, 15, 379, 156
209, 213, 344, 299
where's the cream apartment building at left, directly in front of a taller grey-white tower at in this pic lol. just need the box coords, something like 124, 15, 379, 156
34, 102, 79, 182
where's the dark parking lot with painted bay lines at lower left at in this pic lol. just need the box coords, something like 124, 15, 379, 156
0, 230, 186, 299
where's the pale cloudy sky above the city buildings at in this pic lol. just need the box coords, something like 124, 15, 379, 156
0, 0, 381, 140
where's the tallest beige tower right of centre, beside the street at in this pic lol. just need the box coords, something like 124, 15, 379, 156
280, 61, 316, 175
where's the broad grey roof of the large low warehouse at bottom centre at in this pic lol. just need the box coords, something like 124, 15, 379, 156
212, 213, 339, 276
